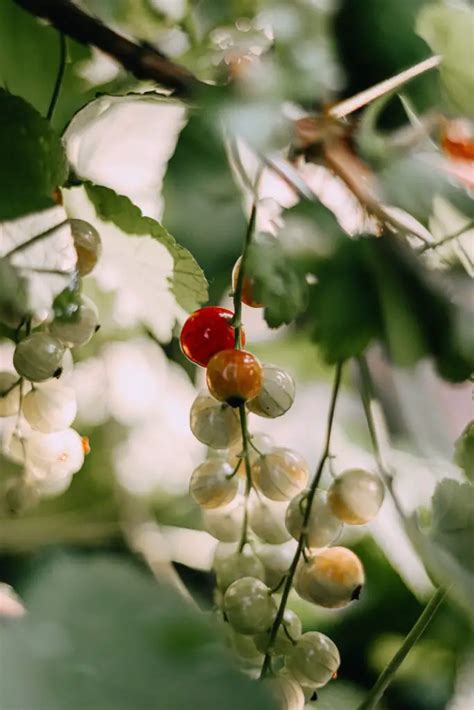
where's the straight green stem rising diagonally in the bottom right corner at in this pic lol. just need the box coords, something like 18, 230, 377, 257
357, 589, 446, 710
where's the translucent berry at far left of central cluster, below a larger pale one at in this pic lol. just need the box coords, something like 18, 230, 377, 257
189, 459, 239, 508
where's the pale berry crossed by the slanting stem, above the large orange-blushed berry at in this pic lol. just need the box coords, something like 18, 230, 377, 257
286, 490, 342, 547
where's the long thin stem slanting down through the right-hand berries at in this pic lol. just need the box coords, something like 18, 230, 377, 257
260, 363, 343, 679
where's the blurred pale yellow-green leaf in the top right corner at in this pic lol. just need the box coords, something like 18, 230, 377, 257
416, 4, 474, 118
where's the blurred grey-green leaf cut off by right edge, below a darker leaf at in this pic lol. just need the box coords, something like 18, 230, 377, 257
430, 478, 474, 573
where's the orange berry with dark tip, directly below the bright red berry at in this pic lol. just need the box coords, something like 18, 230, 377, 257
206, 348, 263, 407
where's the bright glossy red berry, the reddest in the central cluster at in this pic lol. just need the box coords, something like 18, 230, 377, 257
180, 306, 245, 367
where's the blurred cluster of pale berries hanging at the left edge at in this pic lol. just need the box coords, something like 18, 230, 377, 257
0, 219, 102, 511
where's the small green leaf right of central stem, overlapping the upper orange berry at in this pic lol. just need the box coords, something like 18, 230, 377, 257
247, 239, 308, 328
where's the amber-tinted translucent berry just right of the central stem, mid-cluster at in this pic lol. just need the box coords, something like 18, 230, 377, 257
252, 448, 309, 501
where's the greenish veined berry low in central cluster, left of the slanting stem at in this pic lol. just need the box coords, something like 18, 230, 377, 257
224, 577, 277, 636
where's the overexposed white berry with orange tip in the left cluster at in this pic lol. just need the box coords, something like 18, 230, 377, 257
25, 429, 84, 480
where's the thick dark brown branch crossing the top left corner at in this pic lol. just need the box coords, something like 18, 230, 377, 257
15, 0, 206, 96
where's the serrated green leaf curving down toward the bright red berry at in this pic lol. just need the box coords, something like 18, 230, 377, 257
85, 183, 208, 312
